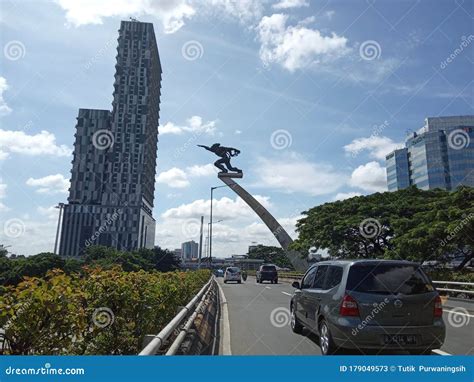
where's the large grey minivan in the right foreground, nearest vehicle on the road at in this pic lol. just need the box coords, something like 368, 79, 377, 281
290, 260, 446, 355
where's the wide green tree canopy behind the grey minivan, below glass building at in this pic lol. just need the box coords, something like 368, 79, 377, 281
293, 187, 474, 266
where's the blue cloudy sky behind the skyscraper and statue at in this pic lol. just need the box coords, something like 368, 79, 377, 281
0, 0, 474, 257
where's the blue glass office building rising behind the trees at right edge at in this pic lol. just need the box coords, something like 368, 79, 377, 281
386, 115, 474, 191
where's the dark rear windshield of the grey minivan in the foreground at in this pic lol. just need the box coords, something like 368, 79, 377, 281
346, 264, 434, 295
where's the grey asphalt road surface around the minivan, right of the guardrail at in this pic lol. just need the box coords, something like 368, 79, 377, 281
218, 277, 474, 355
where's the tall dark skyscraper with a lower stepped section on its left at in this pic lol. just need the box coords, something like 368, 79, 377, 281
59, 21, 162, 256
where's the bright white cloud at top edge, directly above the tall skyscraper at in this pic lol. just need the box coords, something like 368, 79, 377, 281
56, 0, 196, 33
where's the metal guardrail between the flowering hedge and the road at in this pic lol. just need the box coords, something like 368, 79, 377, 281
138, 276, 214, 355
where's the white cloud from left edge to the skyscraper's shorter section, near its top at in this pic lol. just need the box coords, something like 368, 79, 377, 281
0, 129, 71, 159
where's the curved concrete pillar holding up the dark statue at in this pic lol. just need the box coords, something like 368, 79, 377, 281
218, 173, 308, 271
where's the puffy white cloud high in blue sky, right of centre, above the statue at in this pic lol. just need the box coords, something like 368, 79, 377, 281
256, 14, 348, 72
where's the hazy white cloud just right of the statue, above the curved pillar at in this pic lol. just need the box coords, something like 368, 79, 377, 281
258, 154, 347, 196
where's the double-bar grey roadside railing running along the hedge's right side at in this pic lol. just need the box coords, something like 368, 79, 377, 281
138, 277, 214, 355
